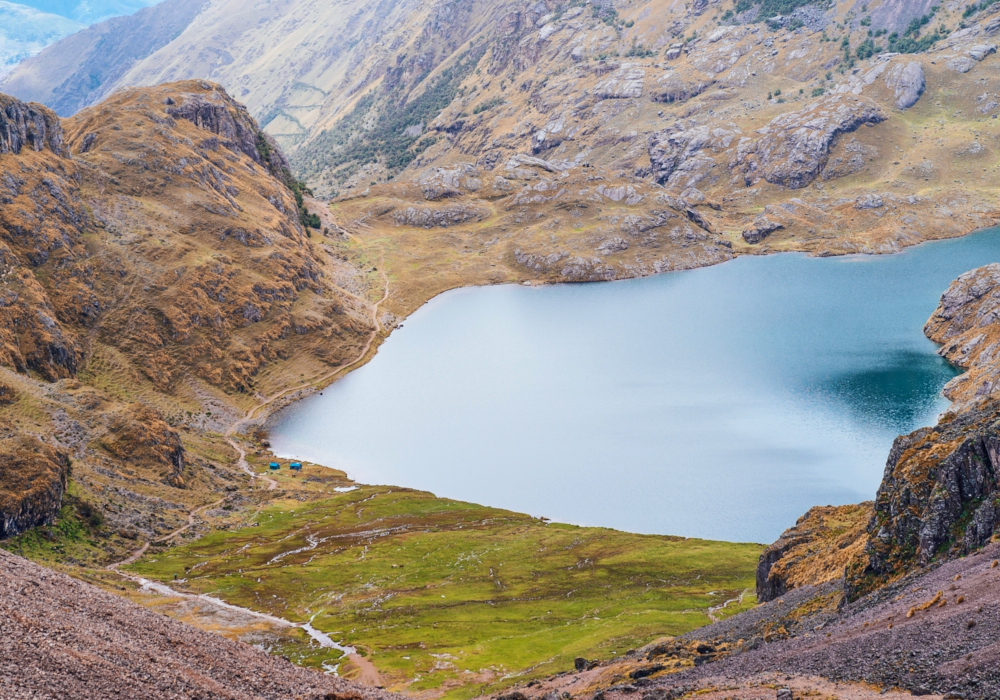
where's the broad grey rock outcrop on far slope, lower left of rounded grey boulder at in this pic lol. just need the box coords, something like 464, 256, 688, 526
730, 94, 887, 189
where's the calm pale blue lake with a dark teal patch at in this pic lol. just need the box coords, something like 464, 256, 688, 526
272, 229, 1000, 542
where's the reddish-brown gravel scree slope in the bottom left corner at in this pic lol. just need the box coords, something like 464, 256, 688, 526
0, 550, 398, 700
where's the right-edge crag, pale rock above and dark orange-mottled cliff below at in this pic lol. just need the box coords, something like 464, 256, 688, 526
848, 263, 1000, 596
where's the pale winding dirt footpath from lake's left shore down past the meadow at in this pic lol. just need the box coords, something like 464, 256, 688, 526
106, 216, 389, 688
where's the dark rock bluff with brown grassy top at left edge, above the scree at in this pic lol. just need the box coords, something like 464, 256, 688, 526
0, 437, 69, 539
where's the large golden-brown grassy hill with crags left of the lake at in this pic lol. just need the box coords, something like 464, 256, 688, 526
0, 81, 373, 546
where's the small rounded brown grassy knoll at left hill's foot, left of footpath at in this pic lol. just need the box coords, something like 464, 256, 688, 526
102, 403, 184, 487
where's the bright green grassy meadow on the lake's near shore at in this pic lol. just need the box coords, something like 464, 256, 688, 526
131, 486, 761, 698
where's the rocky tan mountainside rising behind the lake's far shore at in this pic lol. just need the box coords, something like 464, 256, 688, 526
11, 0, 1000, 296
